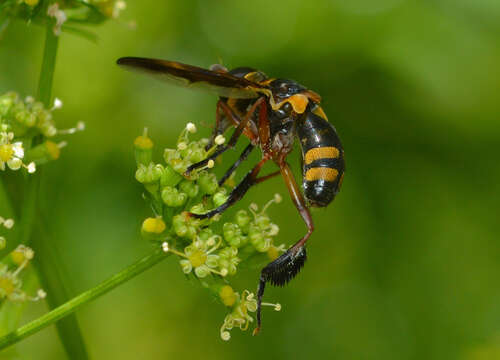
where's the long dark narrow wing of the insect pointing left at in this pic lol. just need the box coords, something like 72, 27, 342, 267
116, 57, 263, 99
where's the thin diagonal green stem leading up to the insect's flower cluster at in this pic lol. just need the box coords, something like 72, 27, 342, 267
0, 249, 169, 350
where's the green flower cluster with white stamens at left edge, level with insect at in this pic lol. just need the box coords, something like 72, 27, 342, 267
0, 92, 84, 174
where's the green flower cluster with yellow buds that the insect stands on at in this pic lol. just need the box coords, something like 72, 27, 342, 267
134, 123, 285, 340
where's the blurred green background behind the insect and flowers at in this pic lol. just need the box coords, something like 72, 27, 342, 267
0, 0, 500, 360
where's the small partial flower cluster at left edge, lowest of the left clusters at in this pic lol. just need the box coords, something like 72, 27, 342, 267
0, 216, 46, 302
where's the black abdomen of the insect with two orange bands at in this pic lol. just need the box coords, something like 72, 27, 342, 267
297, 106, 345, 207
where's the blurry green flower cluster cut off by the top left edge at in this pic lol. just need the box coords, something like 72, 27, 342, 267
0, 0, 126, 35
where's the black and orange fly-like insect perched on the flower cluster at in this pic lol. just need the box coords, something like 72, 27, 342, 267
117, 57, 345, 334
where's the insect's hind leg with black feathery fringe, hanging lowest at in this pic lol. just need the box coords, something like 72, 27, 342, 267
254, 160, 314, 335
